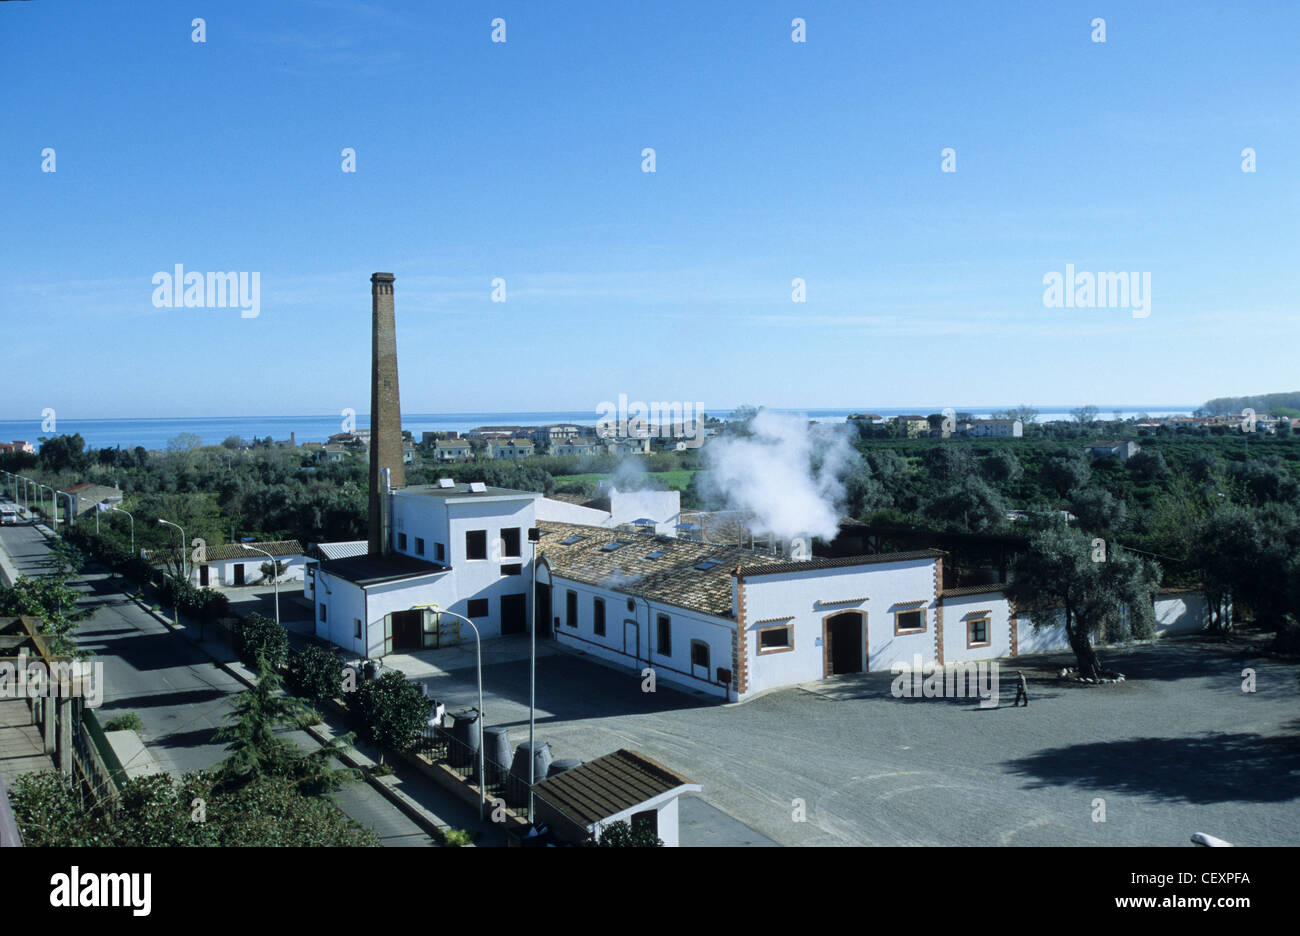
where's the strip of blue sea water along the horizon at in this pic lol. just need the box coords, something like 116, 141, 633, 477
0, 406, 1195, 451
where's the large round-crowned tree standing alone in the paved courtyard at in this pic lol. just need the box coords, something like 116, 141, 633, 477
1008, 529, 1160, 679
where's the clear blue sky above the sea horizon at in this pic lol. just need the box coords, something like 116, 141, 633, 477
0, 0, 1300, 419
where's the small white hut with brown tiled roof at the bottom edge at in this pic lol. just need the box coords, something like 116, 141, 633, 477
533, 750, 701, 848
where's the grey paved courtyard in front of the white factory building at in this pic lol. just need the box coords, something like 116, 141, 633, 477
390, 638, 1300, 845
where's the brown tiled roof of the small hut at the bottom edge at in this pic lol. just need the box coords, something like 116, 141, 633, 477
533, 749, 699, 826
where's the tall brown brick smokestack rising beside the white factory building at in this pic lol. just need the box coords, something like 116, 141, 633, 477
368, 273, 406, 556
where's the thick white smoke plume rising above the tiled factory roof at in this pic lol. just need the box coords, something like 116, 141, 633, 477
705, 410, 858, 540
